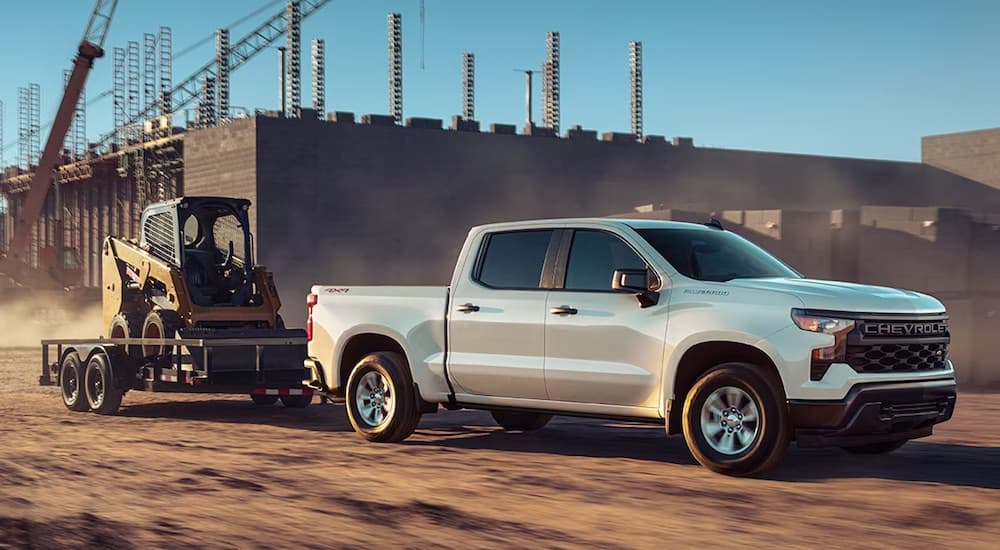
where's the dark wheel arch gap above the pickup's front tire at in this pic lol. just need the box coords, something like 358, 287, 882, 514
664, 340, 784, 434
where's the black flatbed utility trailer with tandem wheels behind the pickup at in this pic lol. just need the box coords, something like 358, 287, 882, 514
38, 330, 315, 414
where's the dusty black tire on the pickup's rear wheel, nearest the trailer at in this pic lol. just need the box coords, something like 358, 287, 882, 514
347, 352, 420, 443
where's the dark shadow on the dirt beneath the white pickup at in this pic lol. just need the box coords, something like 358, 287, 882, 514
411, 413, 1000, 489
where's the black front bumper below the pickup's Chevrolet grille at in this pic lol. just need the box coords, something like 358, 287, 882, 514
788, 379, 955, 447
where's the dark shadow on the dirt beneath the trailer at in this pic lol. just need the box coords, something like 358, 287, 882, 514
118, 399, 352, 432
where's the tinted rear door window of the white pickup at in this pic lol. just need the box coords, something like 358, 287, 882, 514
478, 229, 552, 290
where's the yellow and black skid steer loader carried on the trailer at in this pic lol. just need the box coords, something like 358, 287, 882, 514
102, 197, 311, 406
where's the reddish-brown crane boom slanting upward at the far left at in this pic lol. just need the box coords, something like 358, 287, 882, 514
0, 0, 118, 292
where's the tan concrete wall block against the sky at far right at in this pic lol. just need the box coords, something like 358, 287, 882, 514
920, 128, 1000, 193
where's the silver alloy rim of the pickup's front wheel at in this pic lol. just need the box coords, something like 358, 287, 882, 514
701, 386, 760, 456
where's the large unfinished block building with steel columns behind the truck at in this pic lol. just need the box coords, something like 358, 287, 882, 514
0, 1, 1000, 384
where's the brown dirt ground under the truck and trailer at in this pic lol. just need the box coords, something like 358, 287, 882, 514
0, 349, 1000, 548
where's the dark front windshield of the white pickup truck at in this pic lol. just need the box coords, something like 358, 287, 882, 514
636, 228, 801, 282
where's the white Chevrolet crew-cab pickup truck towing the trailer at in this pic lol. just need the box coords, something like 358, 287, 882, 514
306, 218, 955, 475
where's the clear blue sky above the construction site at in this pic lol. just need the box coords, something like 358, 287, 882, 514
0, 0, 1000, 162
